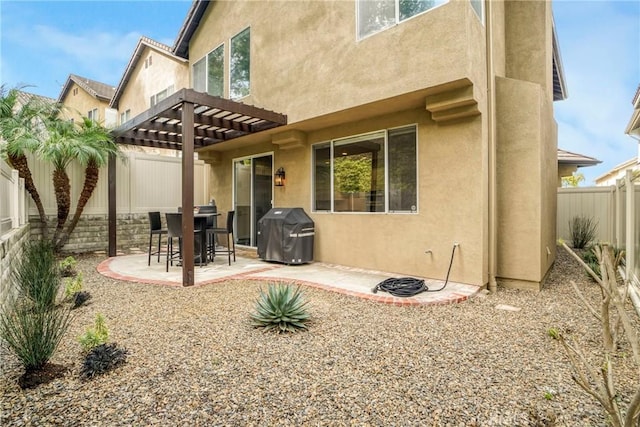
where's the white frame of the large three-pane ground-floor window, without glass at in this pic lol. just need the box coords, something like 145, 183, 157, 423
309, 123, 420, 215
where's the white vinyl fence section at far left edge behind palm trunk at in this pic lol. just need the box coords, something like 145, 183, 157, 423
0, 161, 27, 236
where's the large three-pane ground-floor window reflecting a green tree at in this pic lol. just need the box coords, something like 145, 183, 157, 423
313, 126, 417, 212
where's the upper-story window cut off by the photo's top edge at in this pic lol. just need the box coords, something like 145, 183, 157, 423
357, 0, 448, 39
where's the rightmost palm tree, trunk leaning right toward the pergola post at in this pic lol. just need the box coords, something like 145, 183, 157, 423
54, 117, 124, 250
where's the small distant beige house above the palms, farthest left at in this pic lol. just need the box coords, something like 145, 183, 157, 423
58, 74, 117, 127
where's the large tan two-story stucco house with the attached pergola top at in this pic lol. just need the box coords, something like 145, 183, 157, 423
118, 0, 566, 289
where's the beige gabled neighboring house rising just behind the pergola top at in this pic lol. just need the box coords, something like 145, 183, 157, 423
109, 36, 189, 125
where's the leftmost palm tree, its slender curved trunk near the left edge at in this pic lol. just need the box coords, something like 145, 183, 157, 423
0, 85, 58, 238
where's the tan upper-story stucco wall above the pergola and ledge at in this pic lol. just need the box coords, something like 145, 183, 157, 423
189, 1, 483, 123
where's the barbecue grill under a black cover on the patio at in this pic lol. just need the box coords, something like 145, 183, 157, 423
258, 208, 315, 264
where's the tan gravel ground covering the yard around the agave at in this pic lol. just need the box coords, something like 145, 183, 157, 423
0, 249, 640, 426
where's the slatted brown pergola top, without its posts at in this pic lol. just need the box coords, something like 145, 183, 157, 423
114, 89, 287, 150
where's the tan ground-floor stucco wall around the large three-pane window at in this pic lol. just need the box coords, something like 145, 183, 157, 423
210, 109, 487, 284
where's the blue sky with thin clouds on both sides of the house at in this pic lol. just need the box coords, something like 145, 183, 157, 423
0, 0, 640, 185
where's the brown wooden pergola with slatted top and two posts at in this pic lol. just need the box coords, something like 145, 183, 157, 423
109, 89, 287, 286
